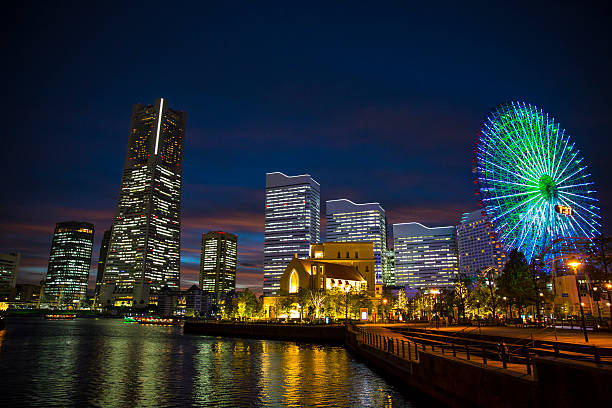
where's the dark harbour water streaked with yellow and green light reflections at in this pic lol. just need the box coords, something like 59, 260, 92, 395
0, 318, 412, 407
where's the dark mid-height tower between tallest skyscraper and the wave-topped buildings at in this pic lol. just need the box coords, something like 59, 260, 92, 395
200, 231, 238, 300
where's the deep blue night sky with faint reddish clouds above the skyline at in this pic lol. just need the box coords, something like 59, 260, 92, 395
0, 2, 612, 290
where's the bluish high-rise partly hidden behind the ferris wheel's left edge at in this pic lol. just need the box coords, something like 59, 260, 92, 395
457, 210, 508, 277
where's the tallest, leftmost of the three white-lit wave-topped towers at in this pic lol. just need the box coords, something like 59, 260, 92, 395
263, 173, 321, 296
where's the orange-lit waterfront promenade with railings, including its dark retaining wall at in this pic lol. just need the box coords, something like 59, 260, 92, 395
345, 324, 612, 407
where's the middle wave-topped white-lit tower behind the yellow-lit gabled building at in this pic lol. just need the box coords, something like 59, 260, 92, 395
325, 199, 387, 283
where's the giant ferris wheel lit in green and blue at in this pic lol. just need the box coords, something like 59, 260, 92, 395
474, 102, 601, 260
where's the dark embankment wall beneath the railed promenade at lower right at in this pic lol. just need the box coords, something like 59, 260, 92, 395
345, 330, 612, 408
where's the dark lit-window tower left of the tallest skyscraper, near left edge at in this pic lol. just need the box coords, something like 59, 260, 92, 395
45, 221, 94, 308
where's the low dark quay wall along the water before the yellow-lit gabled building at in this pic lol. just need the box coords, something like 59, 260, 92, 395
184, 320, 346, 344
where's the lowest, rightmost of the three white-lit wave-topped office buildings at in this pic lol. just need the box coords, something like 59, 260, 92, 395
393, 222, 459, 289
